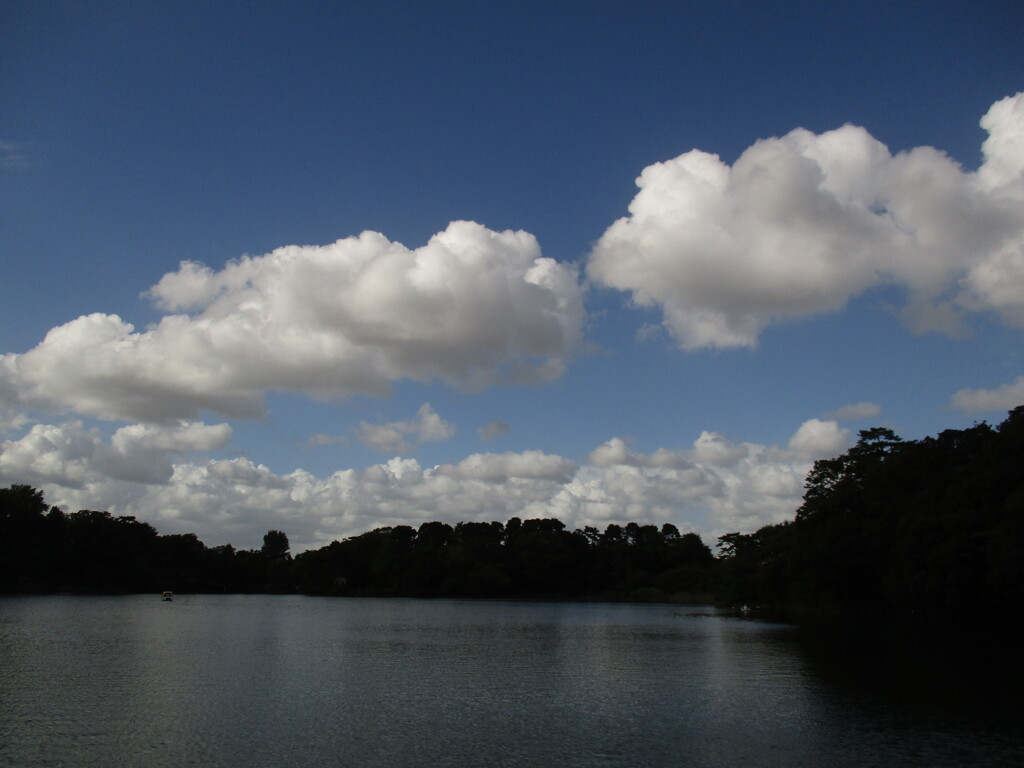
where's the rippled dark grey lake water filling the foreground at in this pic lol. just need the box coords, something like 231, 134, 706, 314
0, 596, 1024, 768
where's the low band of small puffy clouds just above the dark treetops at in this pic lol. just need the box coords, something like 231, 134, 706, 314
0, 420, 848, 552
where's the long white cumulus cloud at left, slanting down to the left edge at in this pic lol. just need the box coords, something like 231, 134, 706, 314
0, 221, 584, 423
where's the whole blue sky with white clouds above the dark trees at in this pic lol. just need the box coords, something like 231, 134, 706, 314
0, 0, 1024, 552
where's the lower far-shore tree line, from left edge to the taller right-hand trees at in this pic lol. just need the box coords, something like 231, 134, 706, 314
0, 484, 715, 600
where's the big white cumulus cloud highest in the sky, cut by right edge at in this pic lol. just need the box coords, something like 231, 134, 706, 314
588, 93, 1024, 349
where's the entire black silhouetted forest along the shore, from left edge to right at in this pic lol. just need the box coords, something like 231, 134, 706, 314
0, 406, 1024, 615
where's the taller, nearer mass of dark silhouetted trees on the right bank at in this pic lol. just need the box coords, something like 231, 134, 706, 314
719, 406, 1024, 615
